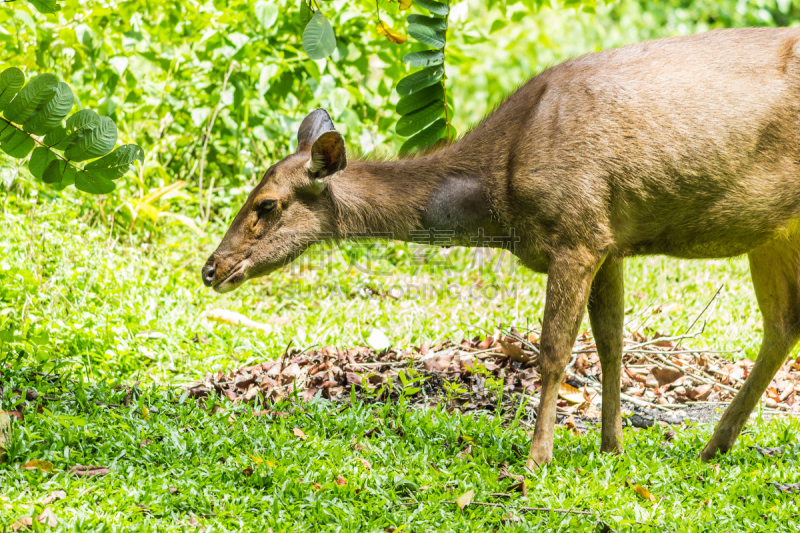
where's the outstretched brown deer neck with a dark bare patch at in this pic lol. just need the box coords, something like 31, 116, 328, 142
329, 146, 502, 246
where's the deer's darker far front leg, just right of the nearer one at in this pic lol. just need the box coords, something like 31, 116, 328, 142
589, 258, 625, 453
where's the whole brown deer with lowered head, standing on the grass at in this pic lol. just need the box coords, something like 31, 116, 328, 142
202, 29, 800, 468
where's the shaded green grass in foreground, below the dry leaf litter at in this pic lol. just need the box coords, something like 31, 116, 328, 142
0, 370, 800, 533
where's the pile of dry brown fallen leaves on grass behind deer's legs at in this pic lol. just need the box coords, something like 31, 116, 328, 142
186, 327, 800, 430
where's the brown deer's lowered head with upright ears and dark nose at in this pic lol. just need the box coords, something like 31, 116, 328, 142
201, 109, 347, 293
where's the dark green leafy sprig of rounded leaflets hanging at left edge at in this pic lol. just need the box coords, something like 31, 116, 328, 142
0, 67, 144, 194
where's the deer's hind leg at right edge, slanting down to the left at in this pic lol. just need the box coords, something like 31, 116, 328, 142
700, 234, 800, 461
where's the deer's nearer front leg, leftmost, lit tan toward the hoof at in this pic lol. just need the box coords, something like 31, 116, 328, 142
526, 251, 602, 469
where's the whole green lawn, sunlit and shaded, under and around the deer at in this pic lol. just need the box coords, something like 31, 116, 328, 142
0, 183, 800, 531
